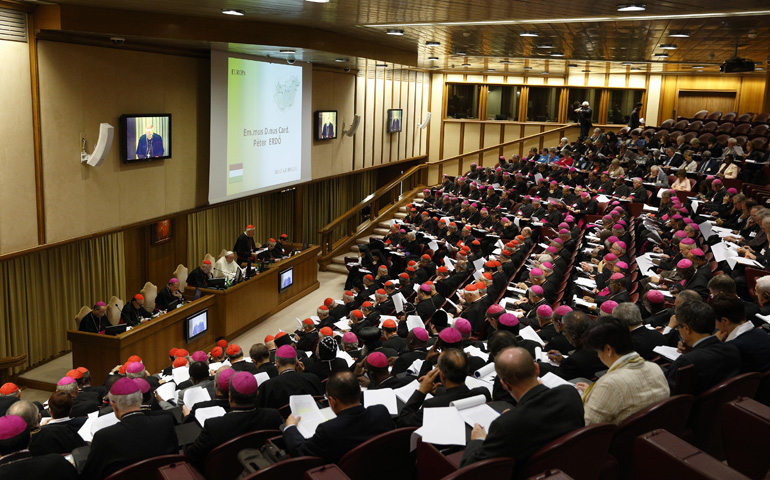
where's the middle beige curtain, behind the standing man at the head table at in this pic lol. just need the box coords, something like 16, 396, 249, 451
187, 190, 299, 271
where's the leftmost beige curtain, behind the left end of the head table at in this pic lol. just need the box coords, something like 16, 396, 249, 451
0, 233, 126, 365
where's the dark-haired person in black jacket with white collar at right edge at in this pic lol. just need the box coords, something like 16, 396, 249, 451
709, 293, 770, 373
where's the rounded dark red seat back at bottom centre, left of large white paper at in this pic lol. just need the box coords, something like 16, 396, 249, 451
337, 427, 417, 480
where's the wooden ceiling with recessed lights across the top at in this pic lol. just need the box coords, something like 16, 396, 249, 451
24, 0, 770, 70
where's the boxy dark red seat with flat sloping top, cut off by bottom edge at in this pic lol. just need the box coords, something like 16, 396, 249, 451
634, 429, 748, 480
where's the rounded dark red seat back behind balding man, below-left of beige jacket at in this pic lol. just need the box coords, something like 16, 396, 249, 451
523, 423, 617, 478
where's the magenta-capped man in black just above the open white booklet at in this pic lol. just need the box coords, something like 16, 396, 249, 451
257, 345, 323, 408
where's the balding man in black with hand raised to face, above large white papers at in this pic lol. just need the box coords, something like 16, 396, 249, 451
396, 348, 492, 427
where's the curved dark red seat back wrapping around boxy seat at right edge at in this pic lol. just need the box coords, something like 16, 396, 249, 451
689, 373, 761, 460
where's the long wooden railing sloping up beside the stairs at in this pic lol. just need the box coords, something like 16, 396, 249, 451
318, 124, 608, 270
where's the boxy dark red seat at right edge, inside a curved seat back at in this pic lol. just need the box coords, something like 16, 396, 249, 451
720, 397, 770, 478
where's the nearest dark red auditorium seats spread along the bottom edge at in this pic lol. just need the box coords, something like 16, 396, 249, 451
99, 378, 770, 480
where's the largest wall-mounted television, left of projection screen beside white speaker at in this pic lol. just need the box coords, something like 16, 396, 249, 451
120, 113, 171, 163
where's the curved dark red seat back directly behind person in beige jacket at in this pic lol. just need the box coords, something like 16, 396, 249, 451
610, 395, 694, 478
